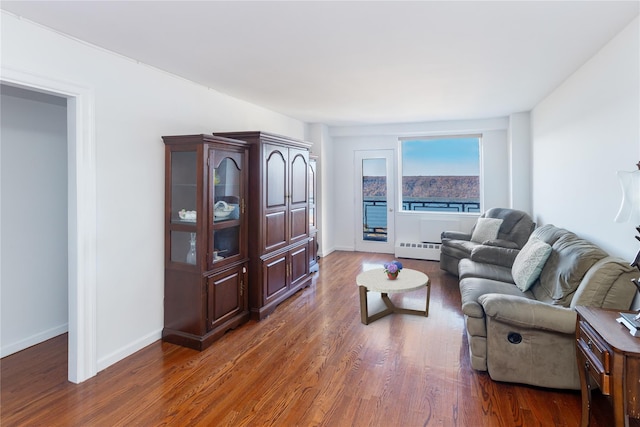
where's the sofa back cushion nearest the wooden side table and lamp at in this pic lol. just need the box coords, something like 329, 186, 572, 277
571, 257, 637, 310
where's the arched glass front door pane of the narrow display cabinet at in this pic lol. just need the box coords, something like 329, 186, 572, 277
209, 151, 244, 266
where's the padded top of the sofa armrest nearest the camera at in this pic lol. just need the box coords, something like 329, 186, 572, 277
478, 294, 577, 334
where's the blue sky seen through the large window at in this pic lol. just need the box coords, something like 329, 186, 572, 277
401, 138, 480, 176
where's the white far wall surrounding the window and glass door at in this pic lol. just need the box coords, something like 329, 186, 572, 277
330, 118, 516, 250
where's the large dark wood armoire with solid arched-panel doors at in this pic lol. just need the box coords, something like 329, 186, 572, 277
215, 132, 311, 320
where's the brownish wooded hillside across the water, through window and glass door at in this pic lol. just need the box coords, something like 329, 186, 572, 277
362, 176, 480, 199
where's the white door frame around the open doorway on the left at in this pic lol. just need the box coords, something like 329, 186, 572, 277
0, 67, 97, 383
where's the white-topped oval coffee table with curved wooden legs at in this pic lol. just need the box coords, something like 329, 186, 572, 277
356, 268, 431, 325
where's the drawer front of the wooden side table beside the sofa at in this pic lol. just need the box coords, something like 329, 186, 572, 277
578, 321, 611, 395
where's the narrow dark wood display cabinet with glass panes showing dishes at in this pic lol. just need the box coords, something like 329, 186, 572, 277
162, 135, 249, 350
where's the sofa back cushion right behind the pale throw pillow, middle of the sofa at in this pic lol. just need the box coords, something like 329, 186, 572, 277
531, 230, 607, 307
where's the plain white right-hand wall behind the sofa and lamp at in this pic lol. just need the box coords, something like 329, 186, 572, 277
531, 18, 640, 261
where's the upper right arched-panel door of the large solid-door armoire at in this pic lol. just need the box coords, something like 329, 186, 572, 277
289, 148, 309, 244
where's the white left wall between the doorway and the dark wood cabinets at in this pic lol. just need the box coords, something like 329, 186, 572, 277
1, 12, 306, 370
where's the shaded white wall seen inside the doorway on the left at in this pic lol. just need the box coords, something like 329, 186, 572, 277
0, 86, 68, 357
